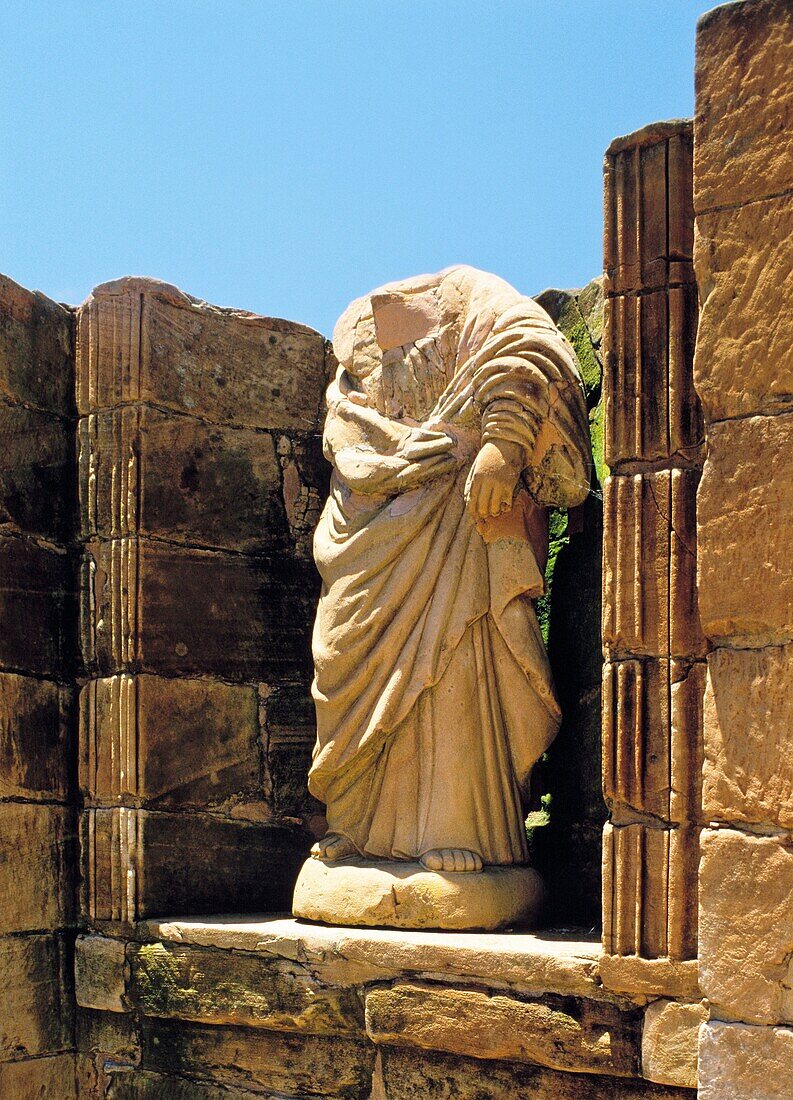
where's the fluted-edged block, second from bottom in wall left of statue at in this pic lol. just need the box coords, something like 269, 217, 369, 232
80, 674, 262, 812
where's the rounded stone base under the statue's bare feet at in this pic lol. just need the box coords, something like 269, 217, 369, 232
293, 858, 543, 932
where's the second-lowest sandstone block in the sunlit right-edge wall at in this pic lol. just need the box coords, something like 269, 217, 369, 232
700, 829, 793, 1024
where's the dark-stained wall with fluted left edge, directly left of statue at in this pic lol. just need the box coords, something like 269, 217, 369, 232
77, 278, 329, 927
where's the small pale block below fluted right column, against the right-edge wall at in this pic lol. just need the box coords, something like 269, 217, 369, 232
641, 1000, 707, 1089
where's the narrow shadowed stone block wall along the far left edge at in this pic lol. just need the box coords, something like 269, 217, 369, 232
0, 276, 77, 1100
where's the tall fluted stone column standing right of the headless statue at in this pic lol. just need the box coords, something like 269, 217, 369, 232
603, 122, 706, 994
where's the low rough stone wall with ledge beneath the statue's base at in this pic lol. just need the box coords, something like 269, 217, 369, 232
72, 917, 700, 1100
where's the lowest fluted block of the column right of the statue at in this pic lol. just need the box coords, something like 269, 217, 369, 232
603, 824, 698, 960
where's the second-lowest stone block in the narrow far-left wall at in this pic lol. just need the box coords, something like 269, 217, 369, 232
0, 936, 73, 1062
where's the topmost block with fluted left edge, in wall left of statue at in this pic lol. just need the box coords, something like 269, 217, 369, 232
77, 278, 330, 432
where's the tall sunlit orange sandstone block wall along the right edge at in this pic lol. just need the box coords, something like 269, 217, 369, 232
694, 0, 793, 1100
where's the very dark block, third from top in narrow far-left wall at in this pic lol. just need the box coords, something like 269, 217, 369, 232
0, 535, 75, 675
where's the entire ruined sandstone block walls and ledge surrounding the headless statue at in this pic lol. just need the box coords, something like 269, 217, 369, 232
0, 0, 793, 1100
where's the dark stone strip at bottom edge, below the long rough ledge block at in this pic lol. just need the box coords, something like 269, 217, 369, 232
373, 1047, 693, 1100
